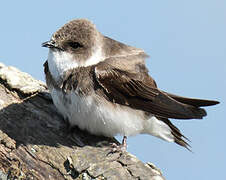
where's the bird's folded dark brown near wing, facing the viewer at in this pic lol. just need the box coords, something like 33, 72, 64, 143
95, 62, 206, 119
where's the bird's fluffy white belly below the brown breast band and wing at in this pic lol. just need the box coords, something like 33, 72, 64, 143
51, 89, 144, 137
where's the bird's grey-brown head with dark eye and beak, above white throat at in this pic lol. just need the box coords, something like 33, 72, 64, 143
42, 19, 103, 63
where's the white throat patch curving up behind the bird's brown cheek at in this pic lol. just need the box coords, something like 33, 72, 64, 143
48, 48, 105, 82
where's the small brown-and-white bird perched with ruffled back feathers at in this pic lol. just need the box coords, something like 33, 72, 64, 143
42, 19, 219, 150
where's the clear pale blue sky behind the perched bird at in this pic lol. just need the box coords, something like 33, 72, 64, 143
0, 0, 226, 180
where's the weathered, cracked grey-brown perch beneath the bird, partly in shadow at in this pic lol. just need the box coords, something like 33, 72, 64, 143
0, 63, 164, 180
